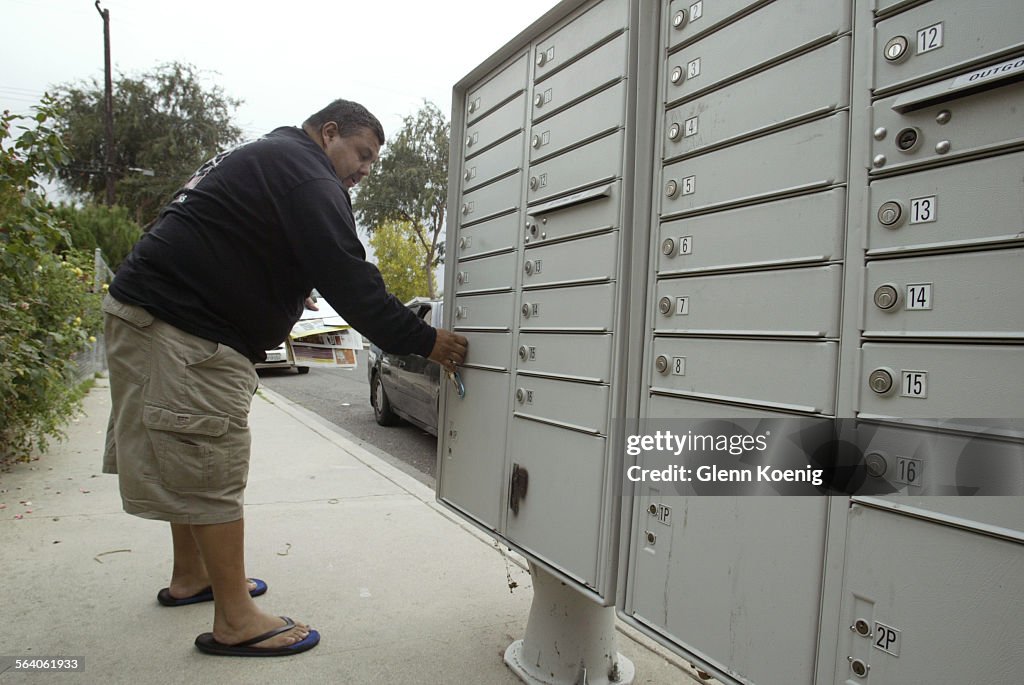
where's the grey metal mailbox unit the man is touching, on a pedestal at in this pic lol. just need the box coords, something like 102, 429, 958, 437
438, 0, 632, 595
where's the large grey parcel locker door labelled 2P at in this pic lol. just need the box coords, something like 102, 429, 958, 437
835, 498, 1024, 685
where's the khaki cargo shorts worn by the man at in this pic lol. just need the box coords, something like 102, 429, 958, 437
103, 295, 259, 524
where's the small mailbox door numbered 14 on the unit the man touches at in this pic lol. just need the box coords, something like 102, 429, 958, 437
519, 283, 615, 333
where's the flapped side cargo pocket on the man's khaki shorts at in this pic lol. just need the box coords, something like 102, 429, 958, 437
142, 404, 250, 491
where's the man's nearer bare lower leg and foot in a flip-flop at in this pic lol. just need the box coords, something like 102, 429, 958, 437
190, 519, 309, 647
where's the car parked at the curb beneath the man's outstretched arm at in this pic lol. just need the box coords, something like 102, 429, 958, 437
367, 297, 443, 435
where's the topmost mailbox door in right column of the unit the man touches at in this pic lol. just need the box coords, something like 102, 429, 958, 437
534, 0, 629, 81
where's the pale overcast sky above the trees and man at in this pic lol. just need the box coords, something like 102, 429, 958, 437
0, 0, 557, 137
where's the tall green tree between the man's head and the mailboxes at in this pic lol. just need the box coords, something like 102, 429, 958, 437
353, 101, 452, 297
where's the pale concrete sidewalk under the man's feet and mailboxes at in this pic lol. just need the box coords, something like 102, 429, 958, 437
0, 379, 693, 685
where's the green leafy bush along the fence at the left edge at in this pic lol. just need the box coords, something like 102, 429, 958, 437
0, 97, 101, 465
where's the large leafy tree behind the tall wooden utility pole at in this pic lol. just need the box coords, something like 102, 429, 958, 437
55, 62, 242, 225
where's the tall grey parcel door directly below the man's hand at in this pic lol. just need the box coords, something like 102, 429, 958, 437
437, 368, 511, 530
